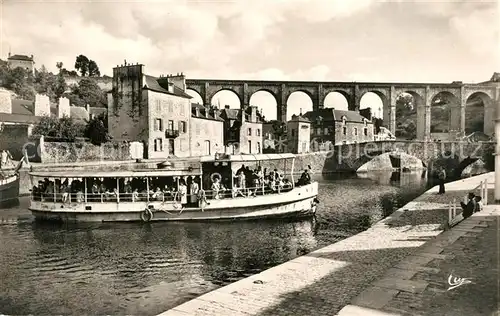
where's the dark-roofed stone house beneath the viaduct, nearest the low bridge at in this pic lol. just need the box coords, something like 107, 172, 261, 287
303, 108, 374, 150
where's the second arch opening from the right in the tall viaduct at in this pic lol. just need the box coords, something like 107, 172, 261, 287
430, 91, 460, 139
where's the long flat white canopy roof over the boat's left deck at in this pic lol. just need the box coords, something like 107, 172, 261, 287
29, 169, 201, 178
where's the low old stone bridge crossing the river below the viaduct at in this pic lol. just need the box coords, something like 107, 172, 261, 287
325, 141, 496, 173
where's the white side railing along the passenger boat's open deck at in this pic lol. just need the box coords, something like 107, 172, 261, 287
31, 185, 308, 203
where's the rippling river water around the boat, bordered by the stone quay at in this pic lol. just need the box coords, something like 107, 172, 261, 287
0, 172, 428, 315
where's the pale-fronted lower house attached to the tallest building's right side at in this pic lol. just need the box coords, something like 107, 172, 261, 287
189, 104, 224, 156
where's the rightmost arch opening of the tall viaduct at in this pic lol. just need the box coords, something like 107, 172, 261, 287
464, 91, 495, 135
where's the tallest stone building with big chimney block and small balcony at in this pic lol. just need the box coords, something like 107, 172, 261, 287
108, 64, 191, 159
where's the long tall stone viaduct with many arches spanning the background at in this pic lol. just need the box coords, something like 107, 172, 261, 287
186, 79, 500, 140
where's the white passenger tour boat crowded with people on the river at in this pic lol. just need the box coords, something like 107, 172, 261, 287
29, 154, 319, 222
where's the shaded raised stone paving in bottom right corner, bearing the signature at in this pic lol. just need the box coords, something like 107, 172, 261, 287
338, 205, 500, 316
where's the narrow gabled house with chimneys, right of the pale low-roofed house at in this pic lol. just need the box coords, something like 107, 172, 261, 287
220, 106, 263, 155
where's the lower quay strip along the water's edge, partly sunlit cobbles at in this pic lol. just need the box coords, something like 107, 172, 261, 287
160, 173, 494, 316
